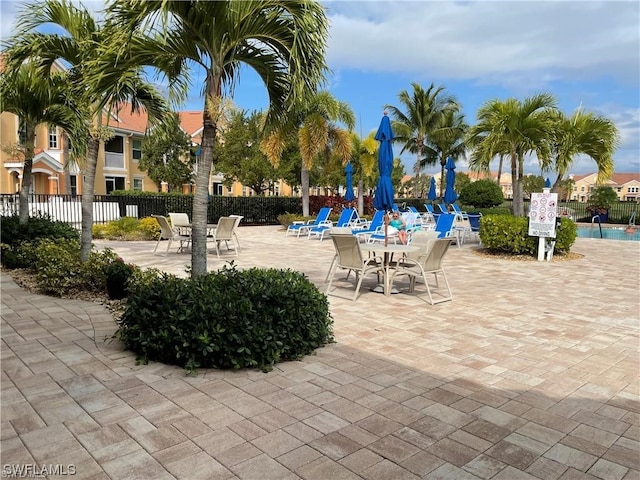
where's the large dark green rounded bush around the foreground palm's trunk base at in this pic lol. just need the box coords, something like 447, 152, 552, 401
115, 263, 333, 373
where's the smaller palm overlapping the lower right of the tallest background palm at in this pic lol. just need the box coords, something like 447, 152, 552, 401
420, 108, 469, 198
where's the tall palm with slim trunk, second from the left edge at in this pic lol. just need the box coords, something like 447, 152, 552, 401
9, 0, 167, 260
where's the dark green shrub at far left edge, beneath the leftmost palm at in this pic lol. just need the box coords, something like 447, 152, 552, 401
0, 215, 80, 269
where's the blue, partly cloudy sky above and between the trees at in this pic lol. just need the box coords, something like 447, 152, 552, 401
0, 0, 640, 174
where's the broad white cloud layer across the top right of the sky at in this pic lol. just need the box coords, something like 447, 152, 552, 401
327, 1, 640, 84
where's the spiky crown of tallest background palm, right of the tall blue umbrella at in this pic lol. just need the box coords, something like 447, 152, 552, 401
385, 83, 460, 176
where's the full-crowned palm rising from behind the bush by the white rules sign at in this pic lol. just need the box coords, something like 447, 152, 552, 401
469, 93, 557, 217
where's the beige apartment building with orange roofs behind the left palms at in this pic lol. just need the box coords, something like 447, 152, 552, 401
0, 104, 296, 196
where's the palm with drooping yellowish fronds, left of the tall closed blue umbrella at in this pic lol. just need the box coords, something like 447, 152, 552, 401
262, 91, 355, 216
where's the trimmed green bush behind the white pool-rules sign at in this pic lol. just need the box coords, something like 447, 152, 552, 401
478, 215, 578, 256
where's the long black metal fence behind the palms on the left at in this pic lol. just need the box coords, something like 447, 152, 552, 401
0, 194, 302, 225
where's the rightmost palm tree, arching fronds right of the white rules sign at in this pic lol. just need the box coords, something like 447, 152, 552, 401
552, 109, 620, 192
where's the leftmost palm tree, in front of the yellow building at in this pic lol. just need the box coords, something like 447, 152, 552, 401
0, 63, 84, 225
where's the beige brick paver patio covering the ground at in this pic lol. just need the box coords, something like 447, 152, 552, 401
0, 227, 640, 480
